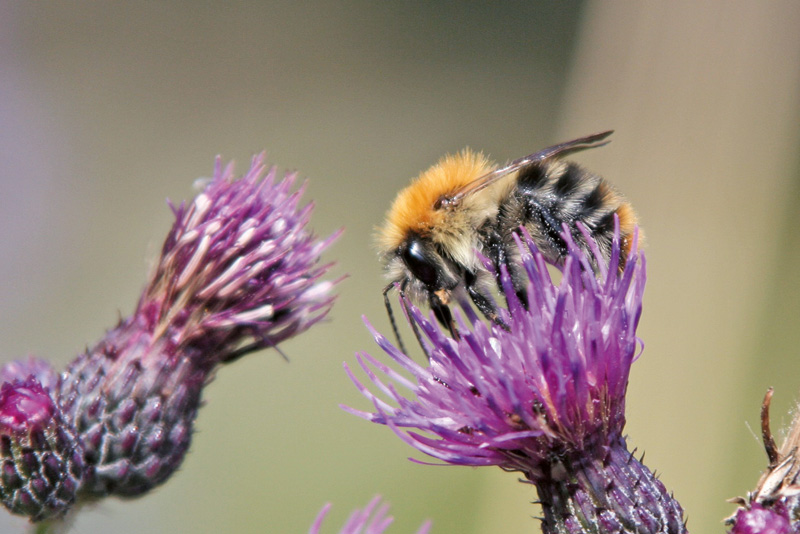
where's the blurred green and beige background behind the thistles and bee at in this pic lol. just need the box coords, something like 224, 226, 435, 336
0, 0, 800, 534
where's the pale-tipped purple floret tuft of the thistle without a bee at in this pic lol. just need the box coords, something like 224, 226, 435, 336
136, 154, 338, 361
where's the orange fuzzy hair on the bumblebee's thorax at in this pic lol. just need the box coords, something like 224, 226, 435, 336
379, 148, 494, 250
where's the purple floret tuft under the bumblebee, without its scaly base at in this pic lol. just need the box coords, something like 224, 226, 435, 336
348, 226, 645, 476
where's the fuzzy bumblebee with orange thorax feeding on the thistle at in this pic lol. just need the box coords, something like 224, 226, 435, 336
379, 131, 641, 349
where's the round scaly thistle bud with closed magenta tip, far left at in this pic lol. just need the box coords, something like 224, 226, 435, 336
0, 372, 84, 521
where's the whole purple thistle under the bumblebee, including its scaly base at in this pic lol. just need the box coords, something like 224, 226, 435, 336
344, 226, 686, 533
